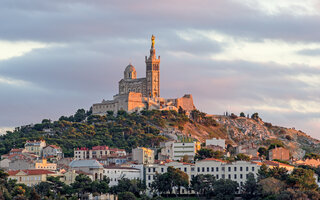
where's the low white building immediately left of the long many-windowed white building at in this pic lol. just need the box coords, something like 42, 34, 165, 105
103, 166, 141, 186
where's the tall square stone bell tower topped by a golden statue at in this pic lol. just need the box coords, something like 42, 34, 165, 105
145, 35, 160, 98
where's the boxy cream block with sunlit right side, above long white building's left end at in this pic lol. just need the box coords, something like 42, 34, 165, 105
132, 147, 154, 164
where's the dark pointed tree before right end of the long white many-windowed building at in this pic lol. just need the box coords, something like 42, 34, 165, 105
242, 173, 261, 199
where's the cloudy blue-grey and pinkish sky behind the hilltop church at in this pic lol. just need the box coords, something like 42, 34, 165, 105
0, 0, 320, 139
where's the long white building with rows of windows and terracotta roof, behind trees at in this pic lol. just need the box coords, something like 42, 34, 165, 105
145, 158, 260, 194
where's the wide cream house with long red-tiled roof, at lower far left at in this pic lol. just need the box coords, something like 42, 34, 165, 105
8, 169, 55, 186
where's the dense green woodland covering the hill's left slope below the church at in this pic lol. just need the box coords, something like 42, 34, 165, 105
0, 109, 189, 156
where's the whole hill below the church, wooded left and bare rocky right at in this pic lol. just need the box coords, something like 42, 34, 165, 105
0, 109, 320, 158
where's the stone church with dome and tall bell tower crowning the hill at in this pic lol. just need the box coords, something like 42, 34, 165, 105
92, 36, 195, 115
